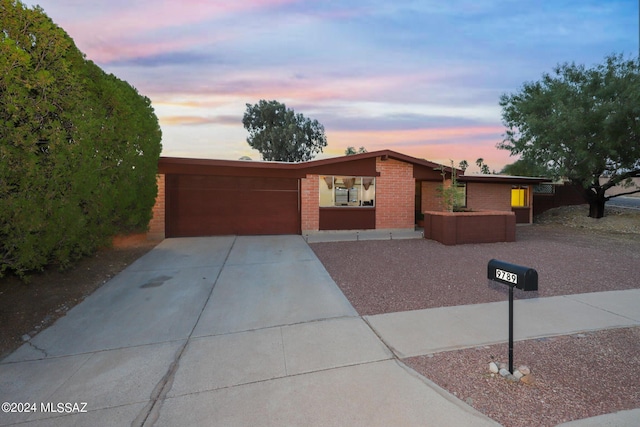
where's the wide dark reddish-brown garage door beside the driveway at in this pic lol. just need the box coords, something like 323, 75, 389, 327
165, 175, 300, 237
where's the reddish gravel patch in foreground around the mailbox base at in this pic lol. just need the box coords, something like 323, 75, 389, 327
403, 328, 640, 427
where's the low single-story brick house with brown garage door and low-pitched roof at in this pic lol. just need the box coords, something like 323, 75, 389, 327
150, 150, 544, 241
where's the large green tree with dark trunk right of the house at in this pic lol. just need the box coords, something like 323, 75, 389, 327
498, 55, 640, 218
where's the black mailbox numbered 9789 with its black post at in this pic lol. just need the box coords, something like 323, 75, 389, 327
487, 259, 538, 374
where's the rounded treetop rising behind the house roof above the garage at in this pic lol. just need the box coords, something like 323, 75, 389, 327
242, 100, 327, 162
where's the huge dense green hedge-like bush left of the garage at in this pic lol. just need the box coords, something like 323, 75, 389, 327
0, 0, 161, 277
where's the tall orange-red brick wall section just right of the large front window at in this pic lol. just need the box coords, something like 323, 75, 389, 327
376, 157, 415, 229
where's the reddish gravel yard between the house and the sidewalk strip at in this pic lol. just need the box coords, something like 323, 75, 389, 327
310, 225, 640, 316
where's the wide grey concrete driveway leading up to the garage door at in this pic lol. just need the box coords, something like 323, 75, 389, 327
0, 236, 497, 426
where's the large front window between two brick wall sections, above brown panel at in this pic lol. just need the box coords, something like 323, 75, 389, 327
320, 175, 376, 207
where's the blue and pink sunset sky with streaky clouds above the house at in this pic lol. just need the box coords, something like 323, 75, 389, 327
24, 0, 639, 171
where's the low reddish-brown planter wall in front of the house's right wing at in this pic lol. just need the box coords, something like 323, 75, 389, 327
424, 211, 516, 245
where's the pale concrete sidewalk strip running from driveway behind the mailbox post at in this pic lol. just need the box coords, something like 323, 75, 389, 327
364, 289, 640, 359
